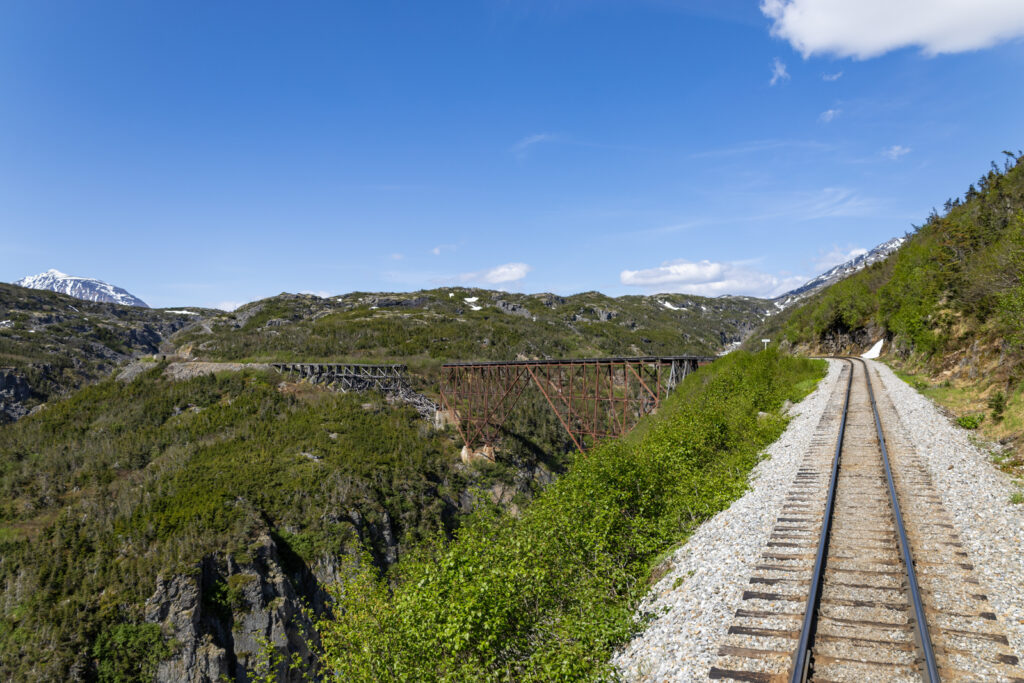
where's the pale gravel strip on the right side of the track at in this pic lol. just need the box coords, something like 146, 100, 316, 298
871, 362, 1024, 655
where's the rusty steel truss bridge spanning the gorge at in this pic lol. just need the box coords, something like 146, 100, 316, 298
441, 355, 714, 451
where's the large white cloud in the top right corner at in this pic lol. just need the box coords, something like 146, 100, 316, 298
761, 0, 1024, 59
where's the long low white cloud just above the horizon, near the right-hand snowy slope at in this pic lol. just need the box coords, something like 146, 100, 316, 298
618, 259, 807, 297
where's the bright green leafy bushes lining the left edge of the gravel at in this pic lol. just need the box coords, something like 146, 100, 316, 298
317, 350, 824, 682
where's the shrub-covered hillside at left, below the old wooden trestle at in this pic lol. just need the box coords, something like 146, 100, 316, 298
0, 365, 511, 681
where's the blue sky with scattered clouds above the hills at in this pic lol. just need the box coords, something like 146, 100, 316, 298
0, 0, 1024, 306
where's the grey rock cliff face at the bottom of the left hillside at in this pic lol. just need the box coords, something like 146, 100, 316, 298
145, 533, 321, 683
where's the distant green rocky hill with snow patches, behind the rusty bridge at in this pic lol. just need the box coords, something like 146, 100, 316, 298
174, 288, 770, 370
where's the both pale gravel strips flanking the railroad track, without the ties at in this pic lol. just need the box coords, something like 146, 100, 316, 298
612, 361, 1024, 682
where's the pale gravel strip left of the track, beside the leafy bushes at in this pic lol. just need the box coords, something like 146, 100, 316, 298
611, 360, 843, 681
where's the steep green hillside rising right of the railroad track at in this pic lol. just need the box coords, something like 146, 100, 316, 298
765, 153, 1024, 467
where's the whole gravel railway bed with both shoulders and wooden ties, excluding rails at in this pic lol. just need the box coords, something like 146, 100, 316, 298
613, 361, 1024, 681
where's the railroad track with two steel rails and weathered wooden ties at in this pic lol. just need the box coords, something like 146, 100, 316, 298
709, 358, 1024, 683
